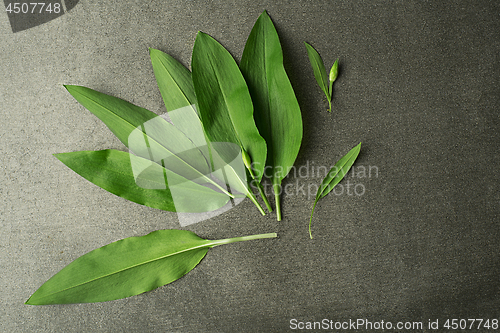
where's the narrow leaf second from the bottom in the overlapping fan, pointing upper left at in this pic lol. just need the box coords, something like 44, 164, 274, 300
65, 85, 232, 196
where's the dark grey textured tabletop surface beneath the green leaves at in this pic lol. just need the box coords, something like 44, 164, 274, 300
0, 0, 500, 332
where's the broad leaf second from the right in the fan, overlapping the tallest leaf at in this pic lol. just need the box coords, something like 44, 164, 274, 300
191, 32, 266, 180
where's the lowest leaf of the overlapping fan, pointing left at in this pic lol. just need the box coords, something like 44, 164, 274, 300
55, 149, 229, 213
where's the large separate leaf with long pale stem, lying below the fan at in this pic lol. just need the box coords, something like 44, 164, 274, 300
26, 230, 277, 305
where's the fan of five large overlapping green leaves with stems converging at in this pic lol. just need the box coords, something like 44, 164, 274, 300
56, 12, 302, 220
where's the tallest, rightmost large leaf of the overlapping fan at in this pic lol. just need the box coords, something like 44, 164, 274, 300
240, 11, 302, 221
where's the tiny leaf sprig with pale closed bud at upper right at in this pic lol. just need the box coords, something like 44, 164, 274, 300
304, 42, 339, 112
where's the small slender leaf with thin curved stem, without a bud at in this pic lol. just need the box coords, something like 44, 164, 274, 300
309, 142, 361, 239
